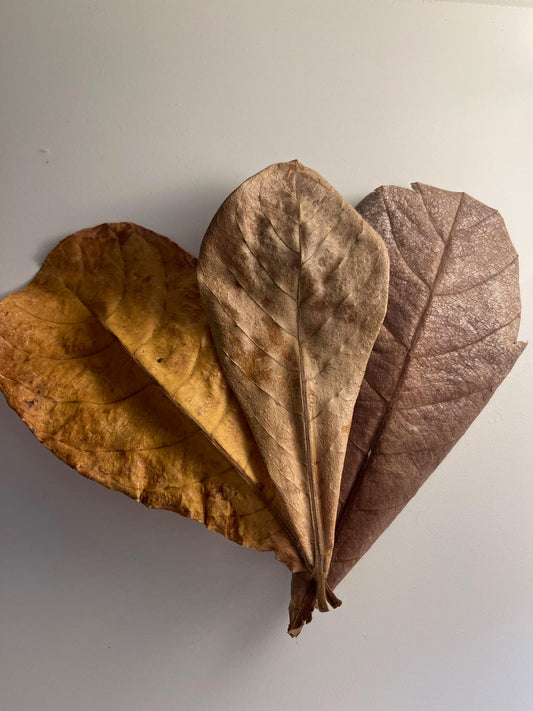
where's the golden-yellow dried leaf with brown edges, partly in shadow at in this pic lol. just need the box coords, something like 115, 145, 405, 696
0, 223, 305, 571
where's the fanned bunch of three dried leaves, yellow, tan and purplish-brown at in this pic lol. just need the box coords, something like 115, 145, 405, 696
0, 161, 525, 635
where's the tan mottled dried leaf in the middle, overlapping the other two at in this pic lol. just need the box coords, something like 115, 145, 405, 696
198, 161, 388, 610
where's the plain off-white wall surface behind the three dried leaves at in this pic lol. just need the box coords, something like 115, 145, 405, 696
0, 0, 533, 711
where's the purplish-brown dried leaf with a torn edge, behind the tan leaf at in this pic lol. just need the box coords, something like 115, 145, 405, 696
289, 183, 526, 635
